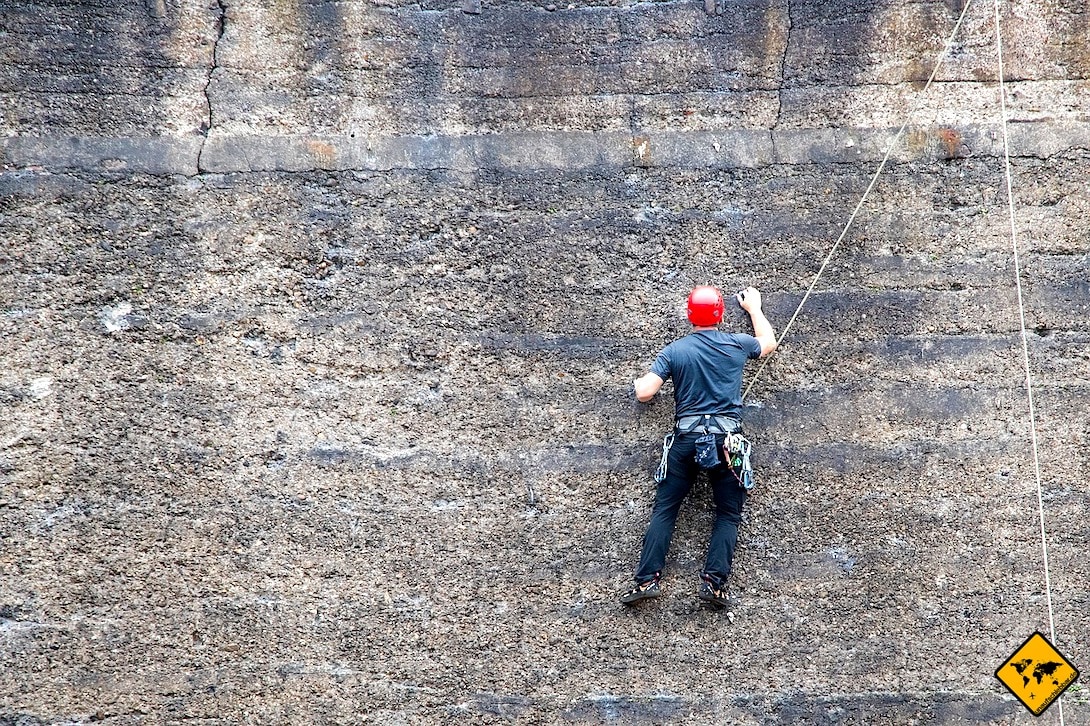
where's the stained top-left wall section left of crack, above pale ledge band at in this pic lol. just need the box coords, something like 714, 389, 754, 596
0, 0, 216, 137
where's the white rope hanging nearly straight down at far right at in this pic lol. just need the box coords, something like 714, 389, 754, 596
994, 0, 1064, 726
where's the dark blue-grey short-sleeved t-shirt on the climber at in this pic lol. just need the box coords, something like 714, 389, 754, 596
651, 330, 761, 419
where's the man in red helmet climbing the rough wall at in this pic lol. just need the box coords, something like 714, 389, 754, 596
620, 286, 776, 607
